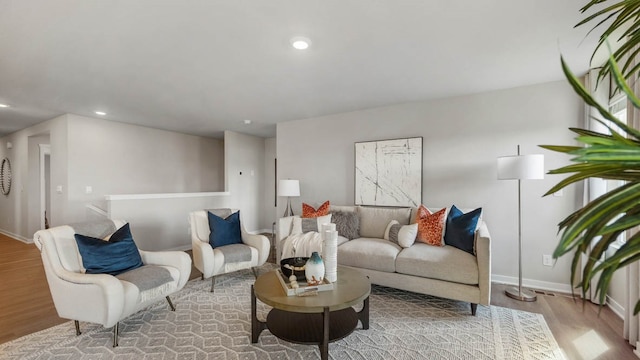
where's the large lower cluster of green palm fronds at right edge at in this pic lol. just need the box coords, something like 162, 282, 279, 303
541, 55, 640, 313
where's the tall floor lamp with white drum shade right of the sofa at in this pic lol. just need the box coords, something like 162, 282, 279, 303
498, 145, 544, 301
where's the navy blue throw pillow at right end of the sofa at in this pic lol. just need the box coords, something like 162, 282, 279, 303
444, 205, 482, 255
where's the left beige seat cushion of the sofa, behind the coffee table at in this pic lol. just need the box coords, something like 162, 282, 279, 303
338, 238, 401, 272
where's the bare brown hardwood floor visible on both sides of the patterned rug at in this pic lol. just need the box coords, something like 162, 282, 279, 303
0, 234, 637, 360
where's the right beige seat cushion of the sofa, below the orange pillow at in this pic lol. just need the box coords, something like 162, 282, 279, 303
398, 243, 478, 285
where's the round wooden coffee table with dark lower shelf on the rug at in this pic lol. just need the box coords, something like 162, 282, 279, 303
251, 266, 371, 360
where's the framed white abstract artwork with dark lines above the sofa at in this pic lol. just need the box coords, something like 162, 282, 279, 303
355, 137, 422, 207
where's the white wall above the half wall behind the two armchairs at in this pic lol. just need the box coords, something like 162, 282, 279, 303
65, 115, 224, 218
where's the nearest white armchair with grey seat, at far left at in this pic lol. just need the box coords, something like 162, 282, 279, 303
34, 220, 191, 347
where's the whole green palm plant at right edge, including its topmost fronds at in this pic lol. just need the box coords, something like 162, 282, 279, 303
542, 0, 640, 314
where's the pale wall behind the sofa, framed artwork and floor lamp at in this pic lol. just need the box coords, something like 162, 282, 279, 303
277, 81, 583, 290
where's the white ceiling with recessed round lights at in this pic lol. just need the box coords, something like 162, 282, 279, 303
0, 0, 596, 137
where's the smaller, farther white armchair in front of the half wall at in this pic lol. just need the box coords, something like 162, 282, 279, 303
189, 209, 271, 292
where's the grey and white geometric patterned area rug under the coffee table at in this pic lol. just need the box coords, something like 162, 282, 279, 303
0, 265, 564, 360
